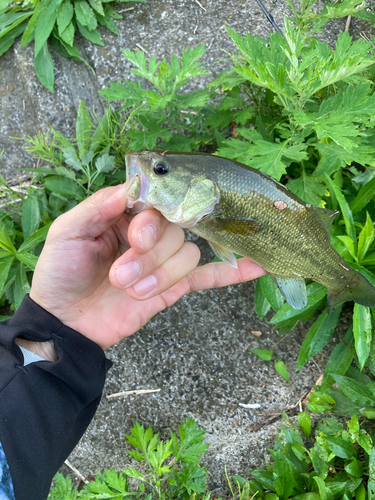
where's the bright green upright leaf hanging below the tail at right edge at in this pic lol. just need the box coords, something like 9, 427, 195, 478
353, 304, 372, 370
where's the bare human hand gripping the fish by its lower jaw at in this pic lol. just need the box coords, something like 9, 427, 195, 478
30, 185, 265, 349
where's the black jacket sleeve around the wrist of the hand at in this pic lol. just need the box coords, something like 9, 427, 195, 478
0, 296, 112, 500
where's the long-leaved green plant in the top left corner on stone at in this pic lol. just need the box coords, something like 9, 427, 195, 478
0, 0, 146, 92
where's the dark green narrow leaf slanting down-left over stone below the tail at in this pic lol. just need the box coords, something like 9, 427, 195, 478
296, 306, 342, 371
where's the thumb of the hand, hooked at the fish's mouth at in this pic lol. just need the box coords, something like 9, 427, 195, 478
51, 184, 128, 239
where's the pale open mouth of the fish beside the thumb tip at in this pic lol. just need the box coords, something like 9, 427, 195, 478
125, 153, 150, 214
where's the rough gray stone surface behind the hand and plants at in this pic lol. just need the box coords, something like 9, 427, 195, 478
0, 0, 374, 496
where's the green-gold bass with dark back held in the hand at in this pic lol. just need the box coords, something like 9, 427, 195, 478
125, 150, 375, 312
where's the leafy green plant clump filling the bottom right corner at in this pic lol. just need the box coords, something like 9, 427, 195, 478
233, 412, 375, 500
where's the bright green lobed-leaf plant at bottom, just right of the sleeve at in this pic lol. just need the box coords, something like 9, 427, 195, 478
49, 418, 209, 500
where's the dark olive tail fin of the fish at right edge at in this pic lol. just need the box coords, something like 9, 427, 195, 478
327, 269, 375, 312
